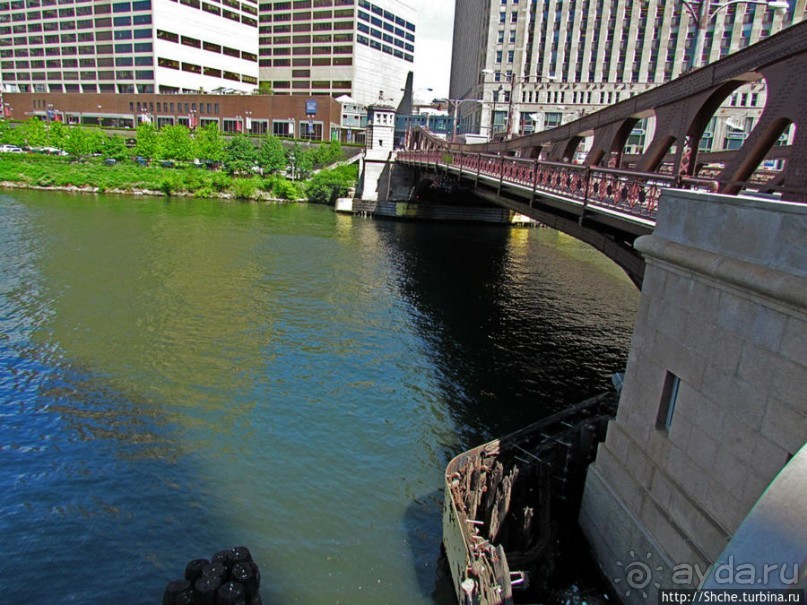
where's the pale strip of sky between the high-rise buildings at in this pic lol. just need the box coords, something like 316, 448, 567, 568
404, 0, 454, 101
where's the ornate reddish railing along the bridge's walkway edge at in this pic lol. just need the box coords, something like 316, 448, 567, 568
397, 150, 718, 220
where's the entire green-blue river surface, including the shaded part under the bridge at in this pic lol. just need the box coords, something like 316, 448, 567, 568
0, 192, 638, 605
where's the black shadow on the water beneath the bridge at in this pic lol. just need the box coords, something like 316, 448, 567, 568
379, 223, 638, 449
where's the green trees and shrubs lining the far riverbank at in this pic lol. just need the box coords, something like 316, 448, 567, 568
0, 120, 358, 203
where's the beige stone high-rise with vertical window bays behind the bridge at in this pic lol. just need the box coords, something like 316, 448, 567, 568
450, 0, 805, 153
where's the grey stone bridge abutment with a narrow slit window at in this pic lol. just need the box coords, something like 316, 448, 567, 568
580, 190, 807, 605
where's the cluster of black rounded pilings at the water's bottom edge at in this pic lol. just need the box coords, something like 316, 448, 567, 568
162, 546, 262, 605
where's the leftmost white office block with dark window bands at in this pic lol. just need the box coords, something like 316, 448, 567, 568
0, 0, 258, 93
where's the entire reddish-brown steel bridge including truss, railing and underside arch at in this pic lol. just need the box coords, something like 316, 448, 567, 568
396, 22, 807, 285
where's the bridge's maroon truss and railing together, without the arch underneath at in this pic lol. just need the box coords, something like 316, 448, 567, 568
408, 21, 807, 205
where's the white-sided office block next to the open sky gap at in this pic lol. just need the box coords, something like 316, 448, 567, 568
259, 0, 415, 105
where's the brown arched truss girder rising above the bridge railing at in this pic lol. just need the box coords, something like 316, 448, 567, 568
410, 22, 807, 202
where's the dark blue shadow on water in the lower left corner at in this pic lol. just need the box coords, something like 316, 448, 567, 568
0, 351, 282, 604
